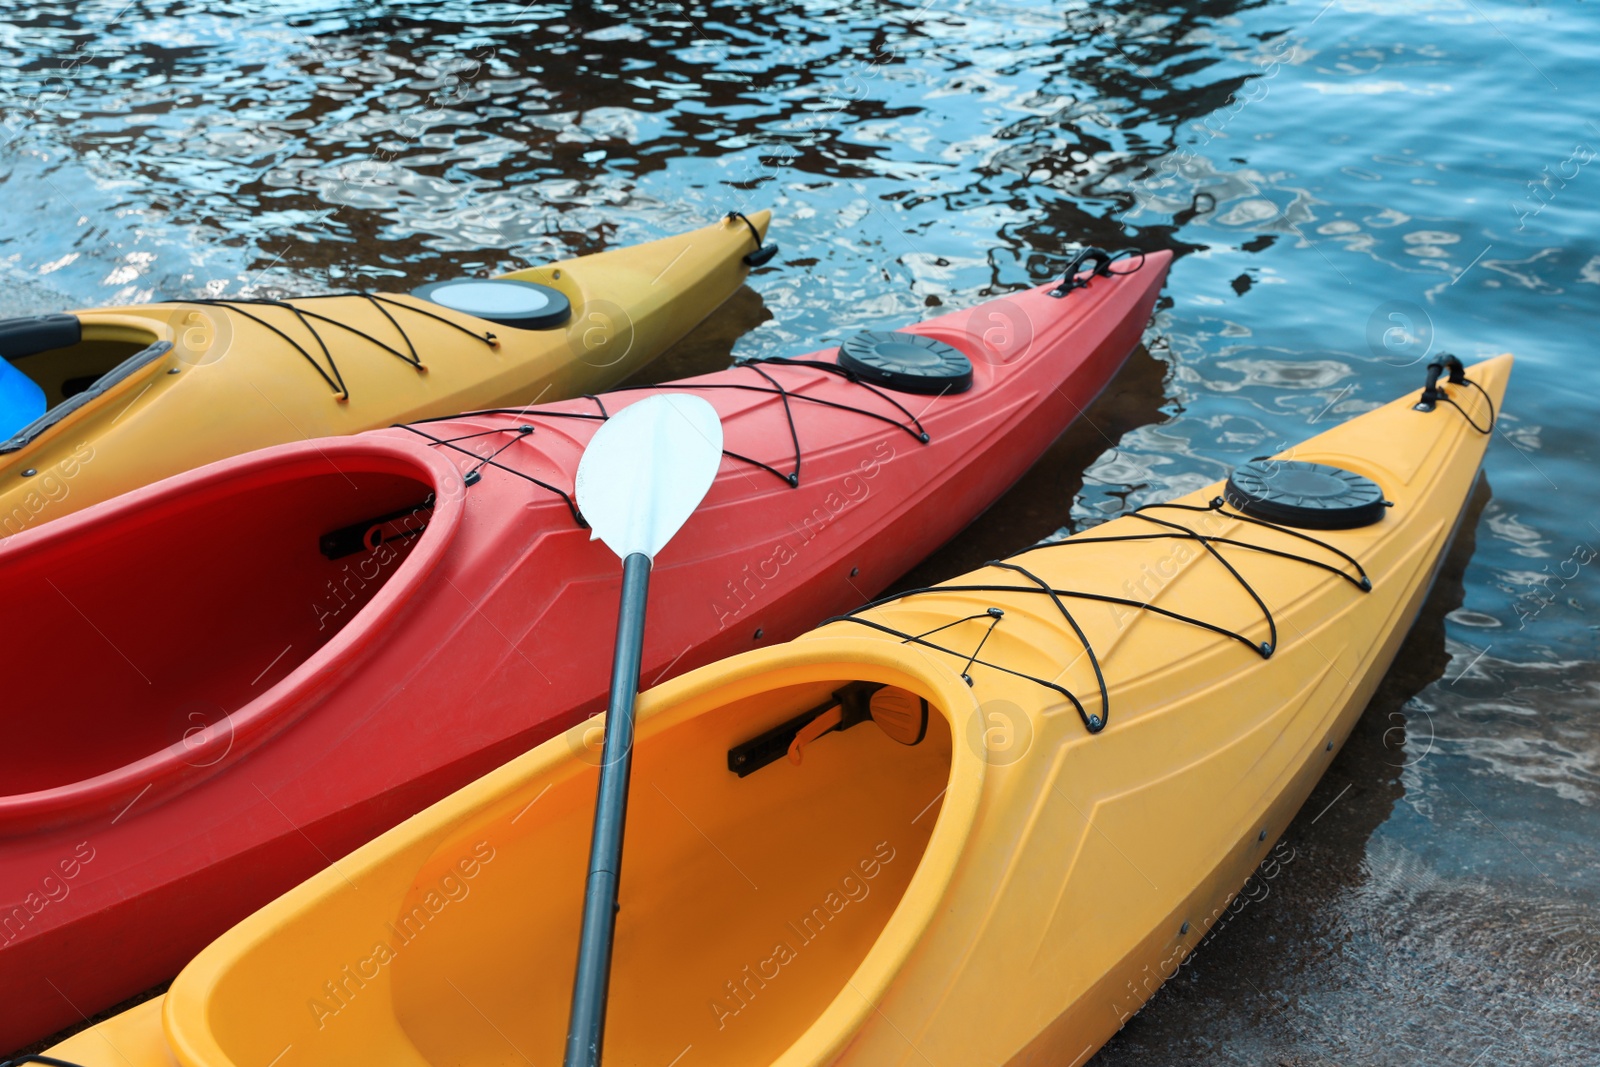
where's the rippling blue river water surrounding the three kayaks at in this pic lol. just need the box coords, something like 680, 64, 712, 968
0, 0, 1600, 1067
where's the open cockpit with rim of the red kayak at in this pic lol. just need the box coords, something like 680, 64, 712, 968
0, 438, 462, 830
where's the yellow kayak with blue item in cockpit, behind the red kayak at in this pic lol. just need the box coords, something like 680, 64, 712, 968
0, 211, 774, 537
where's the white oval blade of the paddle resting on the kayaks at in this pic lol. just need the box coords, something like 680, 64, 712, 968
576, 394, 722, 560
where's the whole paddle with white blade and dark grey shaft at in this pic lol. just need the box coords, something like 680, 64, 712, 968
563, 394, 722, 1067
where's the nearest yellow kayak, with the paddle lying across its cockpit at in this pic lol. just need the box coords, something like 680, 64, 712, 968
50, 357, 1510, 1067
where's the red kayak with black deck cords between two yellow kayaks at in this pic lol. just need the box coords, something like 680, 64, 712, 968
0, 253, 1171, 1049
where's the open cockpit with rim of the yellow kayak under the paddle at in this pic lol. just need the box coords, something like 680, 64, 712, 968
166, 641, 982, 1067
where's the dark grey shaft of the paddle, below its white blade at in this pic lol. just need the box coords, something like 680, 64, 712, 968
563, 552, 650, 1067
